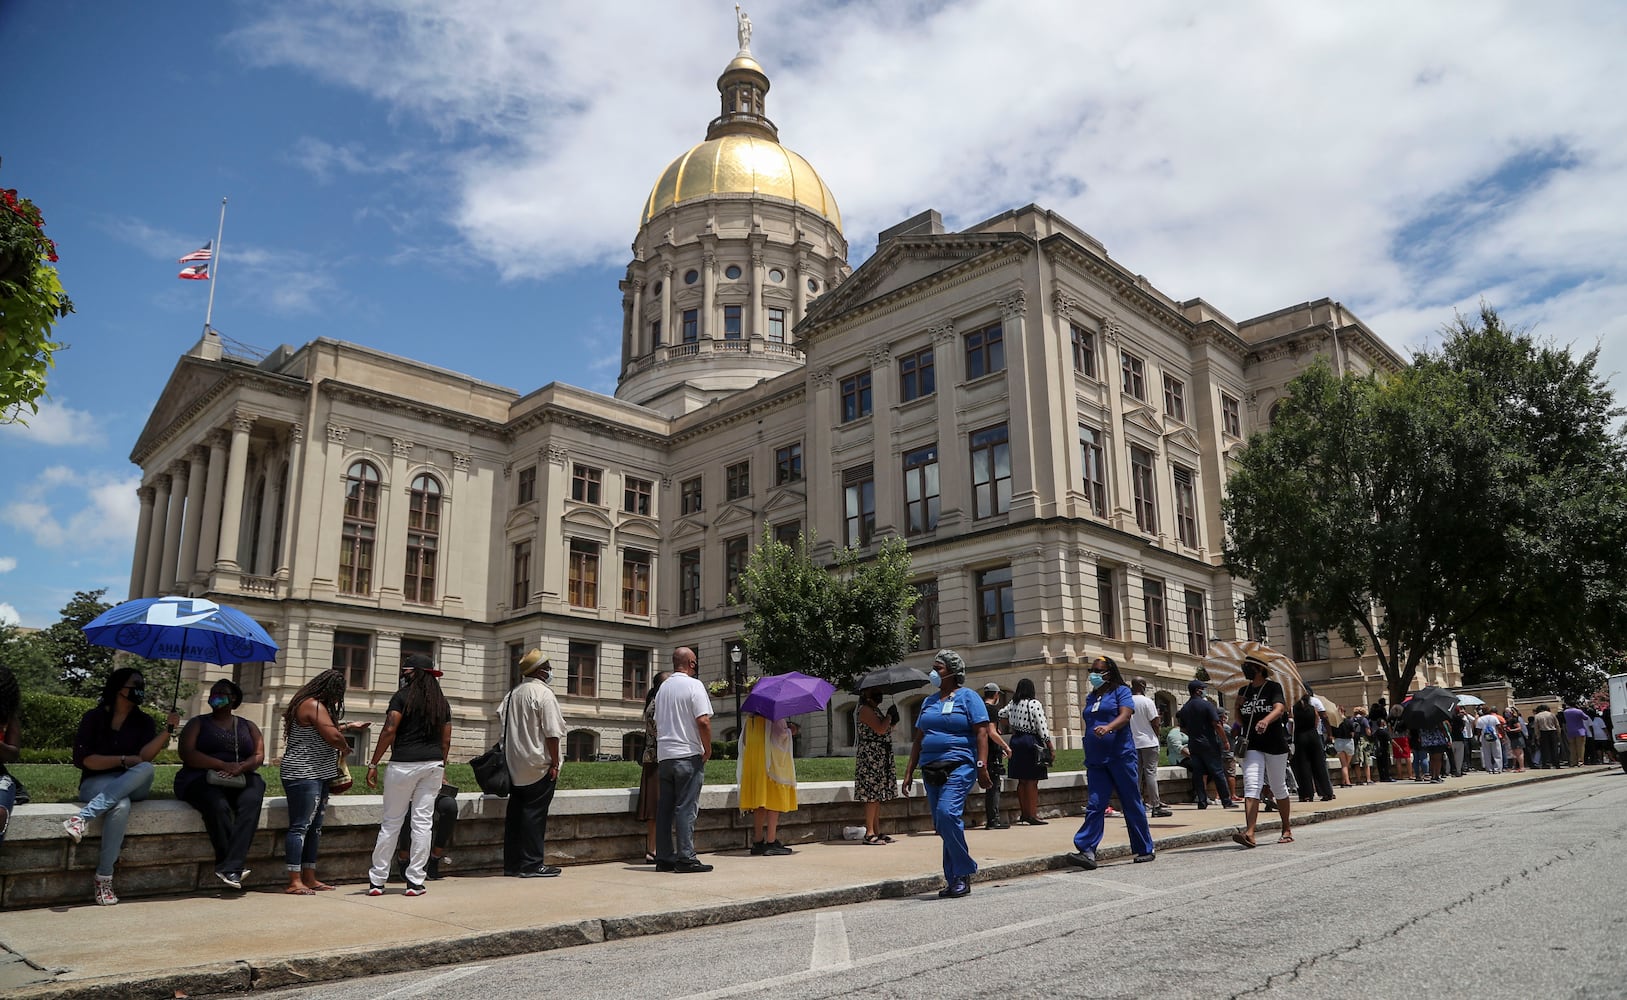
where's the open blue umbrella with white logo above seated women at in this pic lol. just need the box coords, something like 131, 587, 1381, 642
85, 597, 277, 663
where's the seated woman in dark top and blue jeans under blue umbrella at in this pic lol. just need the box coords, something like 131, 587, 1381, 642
62, 667, 181, 906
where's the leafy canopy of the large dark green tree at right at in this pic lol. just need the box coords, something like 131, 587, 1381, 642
1222, 307, 1627, 698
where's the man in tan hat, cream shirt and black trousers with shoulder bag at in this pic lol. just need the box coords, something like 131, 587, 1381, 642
498, 649, 565, 878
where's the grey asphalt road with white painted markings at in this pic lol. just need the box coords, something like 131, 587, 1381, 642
264, 772, 1627, 1000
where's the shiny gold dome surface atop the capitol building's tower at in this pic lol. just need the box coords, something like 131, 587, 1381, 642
639, 134, 841, 231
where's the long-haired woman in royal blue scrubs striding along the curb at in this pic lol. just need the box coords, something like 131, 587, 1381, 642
1067, 657, 1154, 872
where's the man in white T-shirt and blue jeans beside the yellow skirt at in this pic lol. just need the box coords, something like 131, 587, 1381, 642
654, 646, 713, 875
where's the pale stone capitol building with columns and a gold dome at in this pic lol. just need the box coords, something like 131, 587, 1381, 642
120, 21, 1456, 759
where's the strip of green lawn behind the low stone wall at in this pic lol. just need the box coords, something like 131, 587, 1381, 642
10, 750, 1106, 803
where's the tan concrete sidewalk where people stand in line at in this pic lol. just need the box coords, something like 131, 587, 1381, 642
0, 766, 1614, 998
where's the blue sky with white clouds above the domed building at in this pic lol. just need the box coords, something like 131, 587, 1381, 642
0, 0, 1627, 626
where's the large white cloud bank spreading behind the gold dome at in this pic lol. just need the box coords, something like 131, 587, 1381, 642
234, 0, 1627, 364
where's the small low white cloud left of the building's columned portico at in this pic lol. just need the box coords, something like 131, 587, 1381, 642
0, 465, 140, 554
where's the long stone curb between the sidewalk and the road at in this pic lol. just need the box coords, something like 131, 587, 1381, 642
10, 767, 1594, 1000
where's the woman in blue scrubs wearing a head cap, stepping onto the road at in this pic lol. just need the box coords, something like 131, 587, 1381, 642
903, 649, 991, 899
